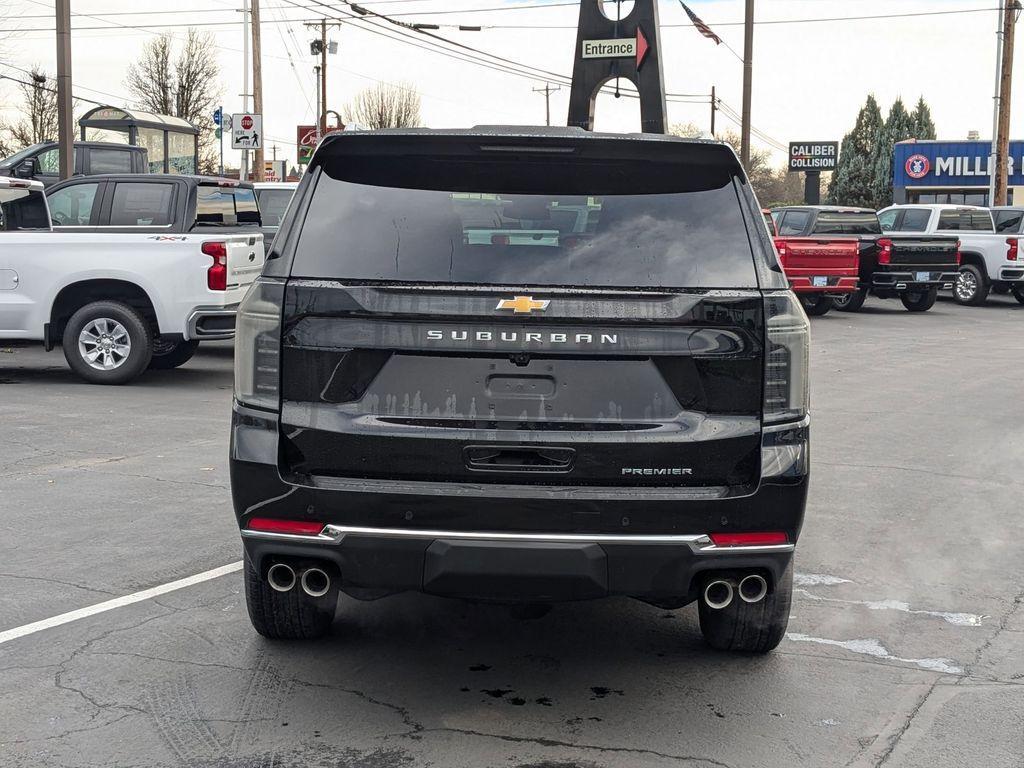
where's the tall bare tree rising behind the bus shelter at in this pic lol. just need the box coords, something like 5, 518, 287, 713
125, 28, 221, 173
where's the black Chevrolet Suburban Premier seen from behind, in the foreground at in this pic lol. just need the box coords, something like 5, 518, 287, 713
230, 128, 809, 651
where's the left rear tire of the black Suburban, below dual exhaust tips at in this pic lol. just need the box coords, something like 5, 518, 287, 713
244, 553, 338, 640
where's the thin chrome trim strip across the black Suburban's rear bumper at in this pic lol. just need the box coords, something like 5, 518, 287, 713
242, 525, 796, 555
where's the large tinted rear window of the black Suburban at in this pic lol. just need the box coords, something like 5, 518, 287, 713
292, 158, 757, 288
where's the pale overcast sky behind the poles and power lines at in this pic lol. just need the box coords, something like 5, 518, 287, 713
0, 0, 1024, 165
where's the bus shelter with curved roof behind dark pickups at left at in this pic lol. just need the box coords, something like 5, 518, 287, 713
78, 106, 199, 173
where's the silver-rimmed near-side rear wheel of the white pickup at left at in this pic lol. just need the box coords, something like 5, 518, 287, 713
61, 301, 153, 384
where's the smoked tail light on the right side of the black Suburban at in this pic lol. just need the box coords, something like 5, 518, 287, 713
764, 292, 811, 422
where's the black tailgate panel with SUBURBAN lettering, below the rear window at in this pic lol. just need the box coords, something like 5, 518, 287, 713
281, 280, 764, 487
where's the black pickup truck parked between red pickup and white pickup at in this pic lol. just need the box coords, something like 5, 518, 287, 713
772, 206, 959, 312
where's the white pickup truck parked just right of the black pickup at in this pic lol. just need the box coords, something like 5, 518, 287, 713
879, 205, 1024, 306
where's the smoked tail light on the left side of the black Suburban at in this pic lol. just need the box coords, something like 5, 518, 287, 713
234, 278, 285, 411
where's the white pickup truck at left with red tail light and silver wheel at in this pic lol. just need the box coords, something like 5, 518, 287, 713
0, 178, 264, 384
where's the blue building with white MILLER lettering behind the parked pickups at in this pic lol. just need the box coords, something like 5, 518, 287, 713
893, 139, 1024, 206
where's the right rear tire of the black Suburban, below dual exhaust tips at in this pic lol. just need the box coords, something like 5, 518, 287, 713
697, 559, 793, 653
